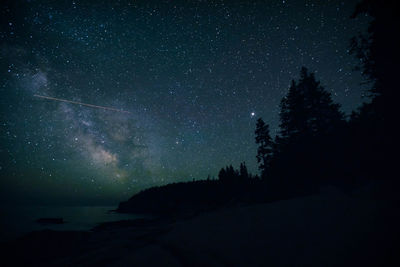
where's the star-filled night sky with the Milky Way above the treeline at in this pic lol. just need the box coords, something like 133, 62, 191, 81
0, 0, 368, 203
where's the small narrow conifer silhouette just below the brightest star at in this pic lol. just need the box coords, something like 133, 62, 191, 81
255, 118, 273, 173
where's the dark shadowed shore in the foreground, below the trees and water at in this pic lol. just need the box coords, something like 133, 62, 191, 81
2, 187, 400, 266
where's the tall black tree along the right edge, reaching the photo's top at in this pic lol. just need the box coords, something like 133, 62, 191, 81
350, 0, 400, 181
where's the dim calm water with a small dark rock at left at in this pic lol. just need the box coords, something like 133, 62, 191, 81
0, 206, 143, 244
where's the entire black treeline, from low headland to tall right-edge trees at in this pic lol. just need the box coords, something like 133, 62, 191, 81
119, 0, 400, 216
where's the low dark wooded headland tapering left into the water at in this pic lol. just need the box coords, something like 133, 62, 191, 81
117, 176, 265, 215
